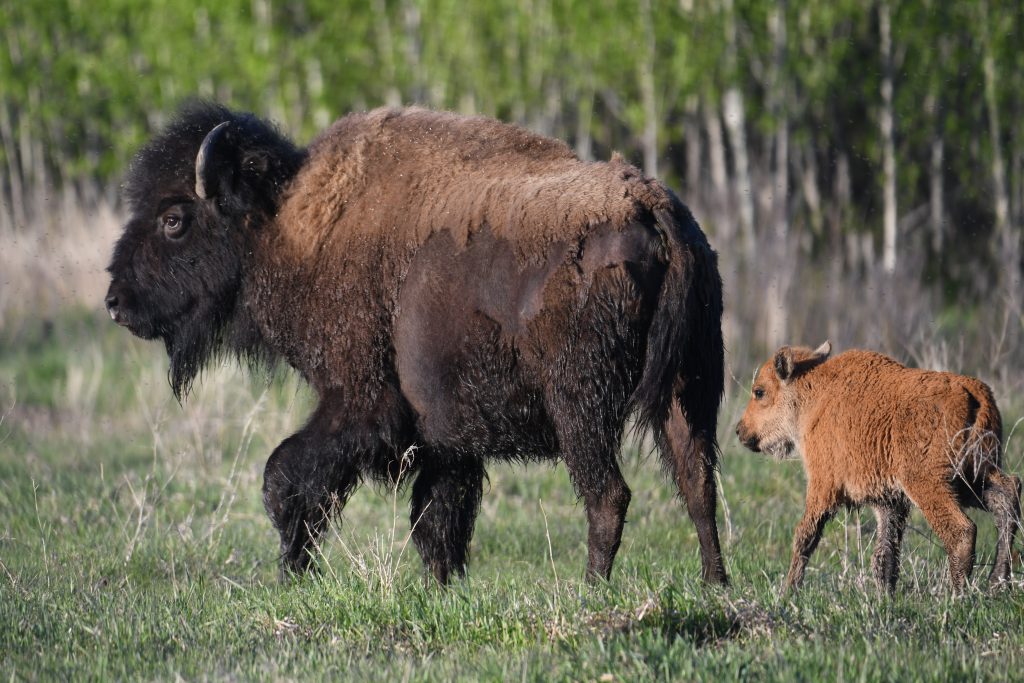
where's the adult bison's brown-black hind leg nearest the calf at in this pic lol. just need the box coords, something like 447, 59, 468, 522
657, 400, 728, 585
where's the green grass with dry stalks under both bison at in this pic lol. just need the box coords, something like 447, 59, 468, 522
0, 314, 1024, 681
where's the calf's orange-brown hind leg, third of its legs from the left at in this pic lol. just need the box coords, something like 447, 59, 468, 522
904, 481, 978, 593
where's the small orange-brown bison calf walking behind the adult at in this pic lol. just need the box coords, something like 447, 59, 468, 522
736, 342, 1021, 592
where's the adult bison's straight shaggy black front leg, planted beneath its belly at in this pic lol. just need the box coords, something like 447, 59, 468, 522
411, 454, 484, 586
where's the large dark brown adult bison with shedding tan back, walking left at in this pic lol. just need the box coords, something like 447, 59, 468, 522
106, 103, 726, 584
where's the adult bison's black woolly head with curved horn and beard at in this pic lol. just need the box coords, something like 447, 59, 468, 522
106, 103, 303, 397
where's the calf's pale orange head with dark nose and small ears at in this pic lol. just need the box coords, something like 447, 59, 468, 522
736, 342, 831, 460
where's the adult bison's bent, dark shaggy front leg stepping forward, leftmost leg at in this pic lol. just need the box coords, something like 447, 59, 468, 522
263, 430, 358, 577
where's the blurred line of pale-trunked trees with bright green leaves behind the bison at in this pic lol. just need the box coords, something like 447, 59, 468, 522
0, 0, 1024, 368
